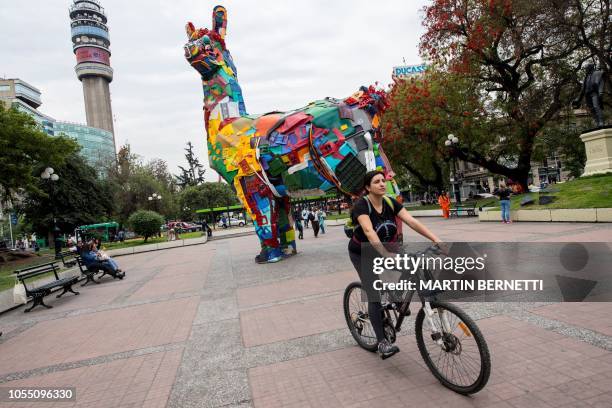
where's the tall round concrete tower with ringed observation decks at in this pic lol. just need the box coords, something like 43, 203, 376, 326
69, 0, 114, 143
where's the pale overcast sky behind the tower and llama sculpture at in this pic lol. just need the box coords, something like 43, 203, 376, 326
0, 0, 428, 180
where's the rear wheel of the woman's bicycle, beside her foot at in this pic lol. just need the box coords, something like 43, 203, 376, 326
344, 282, 378, 352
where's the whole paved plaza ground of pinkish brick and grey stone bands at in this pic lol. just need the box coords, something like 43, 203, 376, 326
0, 218, 612, 408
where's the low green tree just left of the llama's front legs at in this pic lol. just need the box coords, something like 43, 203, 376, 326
179, 183, 239, 219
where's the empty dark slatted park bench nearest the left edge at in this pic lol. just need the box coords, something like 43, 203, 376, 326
13, 262, 79, 313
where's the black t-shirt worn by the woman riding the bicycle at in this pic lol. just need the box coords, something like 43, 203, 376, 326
349, 197, 403, 253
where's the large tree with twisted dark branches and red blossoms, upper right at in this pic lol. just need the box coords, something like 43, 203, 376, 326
421, 0, 588, 188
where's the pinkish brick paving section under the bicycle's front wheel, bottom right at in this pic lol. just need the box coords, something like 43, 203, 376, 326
249, 316, 612, 407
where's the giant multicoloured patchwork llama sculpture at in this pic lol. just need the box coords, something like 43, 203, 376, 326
185, 6, 399, 263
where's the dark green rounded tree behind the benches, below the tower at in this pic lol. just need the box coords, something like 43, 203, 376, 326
19, 153, 114, 235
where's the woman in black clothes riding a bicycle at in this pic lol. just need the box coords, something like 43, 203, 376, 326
348, 170, 441, 358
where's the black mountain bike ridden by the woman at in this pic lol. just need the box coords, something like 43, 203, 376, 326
344, 245, 491, 395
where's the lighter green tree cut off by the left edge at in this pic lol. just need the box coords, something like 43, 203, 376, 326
0, 103, 78, 201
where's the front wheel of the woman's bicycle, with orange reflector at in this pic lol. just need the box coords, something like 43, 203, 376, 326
415, 302, 491, 394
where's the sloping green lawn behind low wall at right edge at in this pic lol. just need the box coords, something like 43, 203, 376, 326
488, 174, 612, 210
